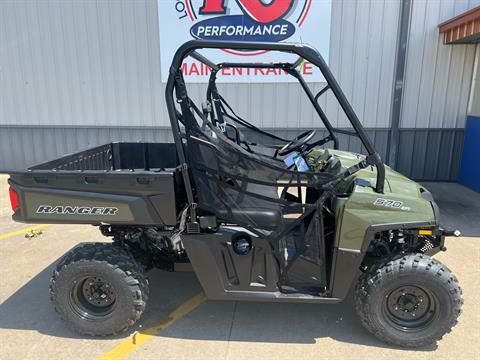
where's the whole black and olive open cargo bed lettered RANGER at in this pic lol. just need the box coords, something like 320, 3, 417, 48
9, 142, 185, 226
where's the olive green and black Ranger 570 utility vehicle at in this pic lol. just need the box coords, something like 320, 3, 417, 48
9, 40, 463, 347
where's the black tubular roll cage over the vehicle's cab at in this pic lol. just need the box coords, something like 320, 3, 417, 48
165, 40, 385, 210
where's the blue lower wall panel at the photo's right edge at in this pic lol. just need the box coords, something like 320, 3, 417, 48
459, 116, 480, 192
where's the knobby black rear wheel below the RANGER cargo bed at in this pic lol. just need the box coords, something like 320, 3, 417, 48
50, 243, 148, 335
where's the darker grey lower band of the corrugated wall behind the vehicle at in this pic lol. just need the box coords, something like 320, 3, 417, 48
0, 127, 463, 181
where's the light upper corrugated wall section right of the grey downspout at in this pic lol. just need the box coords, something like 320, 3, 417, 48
401, 0, 480, 128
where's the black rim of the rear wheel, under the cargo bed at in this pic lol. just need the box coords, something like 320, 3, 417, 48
70, 276, 116, 320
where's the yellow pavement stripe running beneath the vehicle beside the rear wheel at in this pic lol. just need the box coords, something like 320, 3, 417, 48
99, 292, 206, 360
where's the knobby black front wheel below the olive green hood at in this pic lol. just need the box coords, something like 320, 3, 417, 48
355, 254, 463, 347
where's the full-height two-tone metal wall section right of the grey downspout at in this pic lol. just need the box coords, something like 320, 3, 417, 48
397, 0, 480, 180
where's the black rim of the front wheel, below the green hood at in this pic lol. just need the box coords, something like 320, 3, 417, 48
383, 285, 438, 332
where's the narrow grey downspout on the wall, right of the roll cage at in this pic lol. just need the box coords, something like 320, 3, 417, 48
387, 0, 412, 168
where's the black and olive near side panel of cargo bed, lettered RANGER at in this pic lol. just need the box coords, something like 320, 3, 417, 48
9, 172, 177, 226
